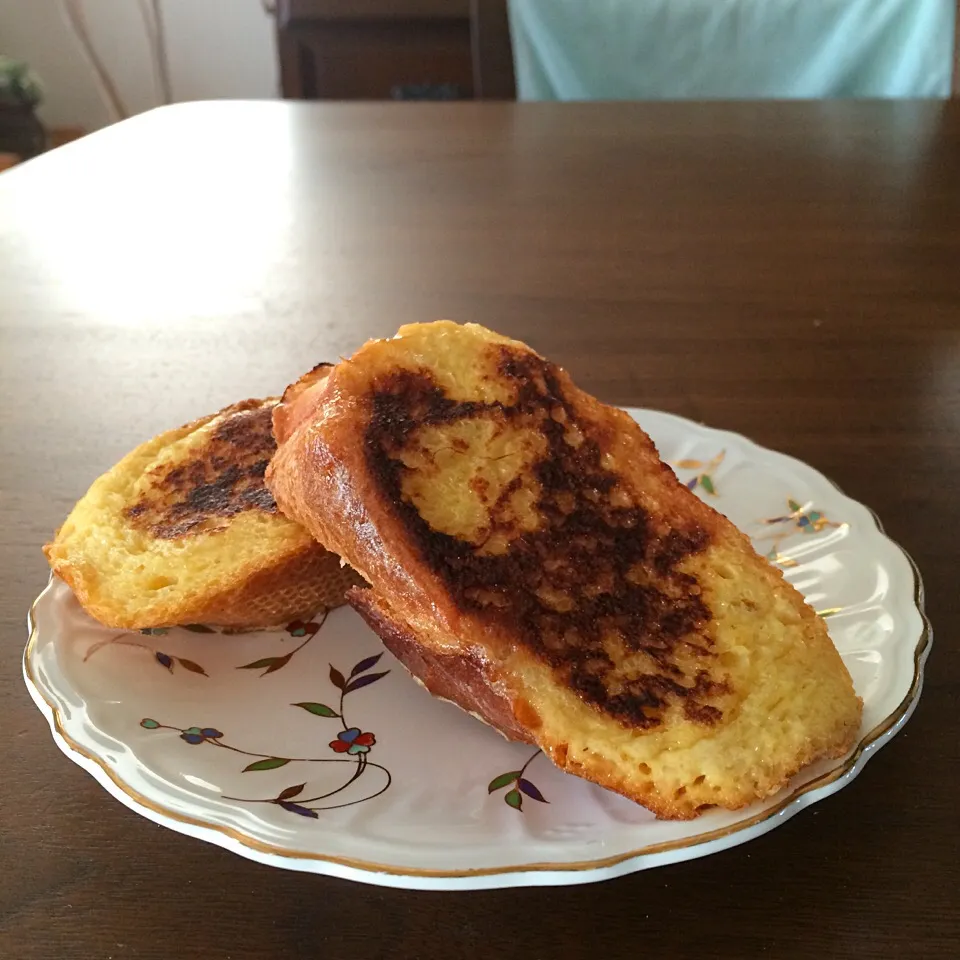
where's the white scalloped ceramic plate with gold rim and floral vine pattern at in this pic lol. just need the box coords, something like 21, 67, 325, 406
24, 410, 930, 889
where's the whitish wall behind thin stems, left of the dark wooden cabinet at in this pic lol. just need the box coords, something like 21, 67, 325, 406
0, 0, 279, 130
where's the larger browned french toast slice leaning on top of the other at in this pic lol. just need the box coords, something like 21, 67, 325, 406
267, 321, 862, 819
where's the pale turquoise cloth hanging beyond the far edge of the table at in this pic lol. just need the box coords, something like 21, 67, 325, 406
509, 0, 956, 100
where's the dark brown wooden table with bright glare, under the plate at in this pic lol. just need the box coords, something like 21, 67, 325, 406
0, 103, 960, 960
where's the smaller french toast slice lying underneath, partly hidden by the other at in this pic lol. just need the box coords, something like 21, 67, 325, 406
43, 382, 362, 630
